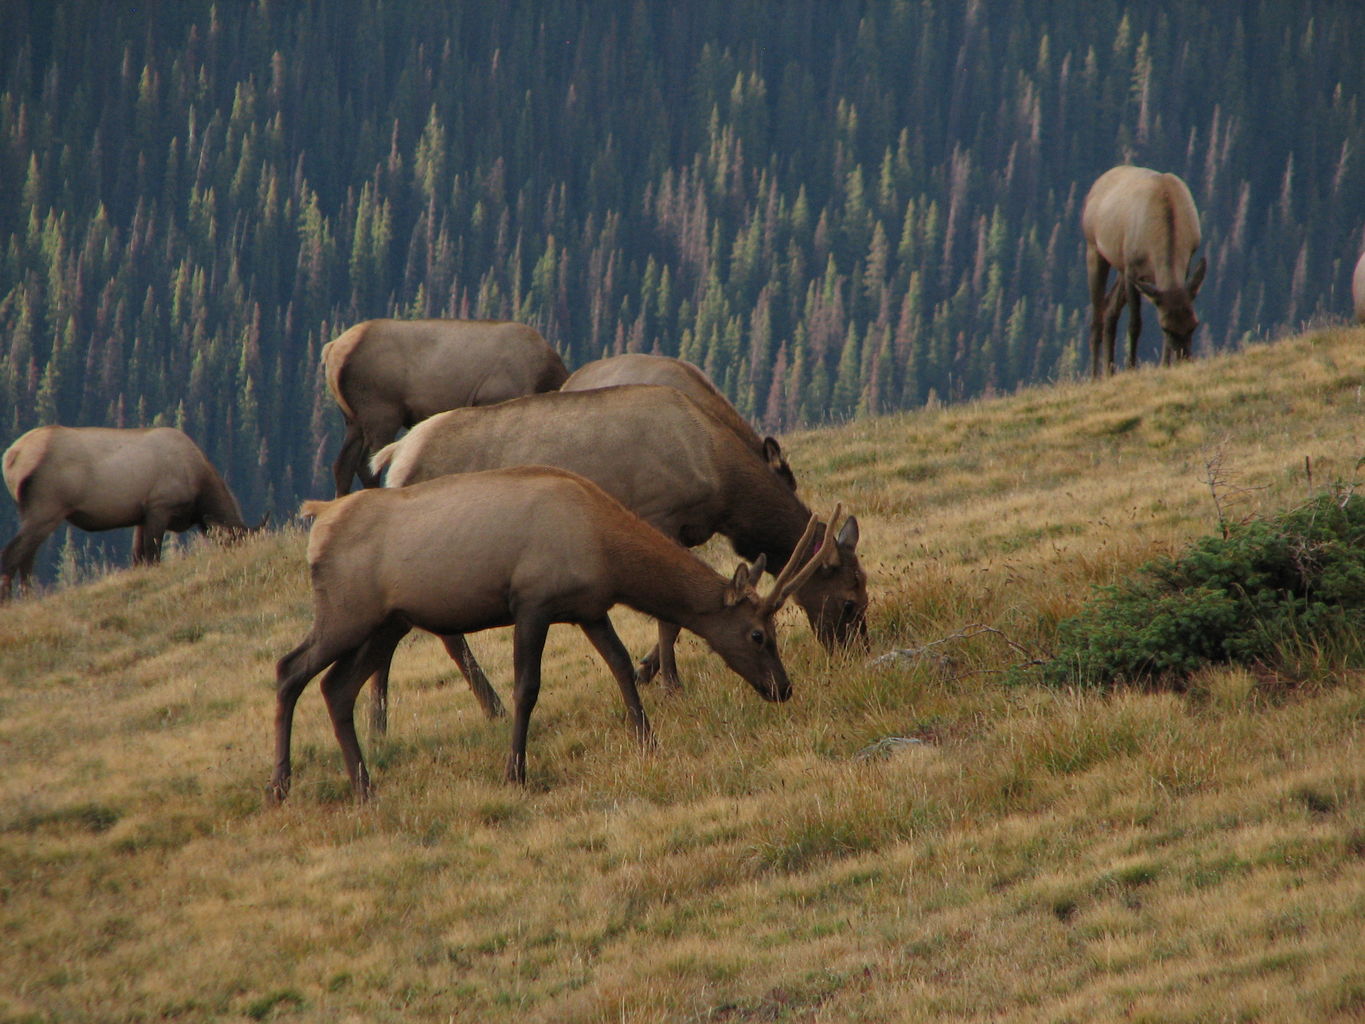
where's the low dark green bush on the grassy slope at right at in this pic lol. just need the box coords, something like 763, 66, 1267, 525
1037, 494, 1365, 685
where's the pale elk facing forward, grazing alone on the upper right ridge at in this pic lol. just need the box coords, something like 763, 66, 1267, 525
1081, 165, 1207, 378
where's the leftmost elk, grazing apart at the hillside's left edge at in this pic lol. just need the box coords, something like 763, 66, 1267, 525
0, 426, 255, 601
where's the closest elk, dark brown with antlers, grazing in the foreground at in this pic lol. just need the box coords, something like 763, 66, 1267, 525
270, 466, 838, 800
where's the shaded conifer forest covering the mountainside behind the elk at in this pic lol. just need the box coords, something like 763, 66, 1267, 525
0, 0, 1365, 570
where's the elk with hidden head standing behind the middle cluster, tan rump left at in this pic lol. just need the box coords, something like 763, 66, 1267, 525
322, 319, 569, 496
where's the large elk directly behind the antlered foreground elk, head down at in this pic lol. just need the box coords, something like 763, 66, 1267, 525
371, 385, 867, 730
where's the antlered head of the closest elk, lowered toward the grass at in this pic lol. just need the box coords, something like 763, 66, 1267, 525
703, 507, 839, 700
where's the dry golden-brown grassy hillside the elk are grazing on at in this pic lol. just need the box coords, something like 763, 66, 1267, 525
0, 329, 1365, 1021
